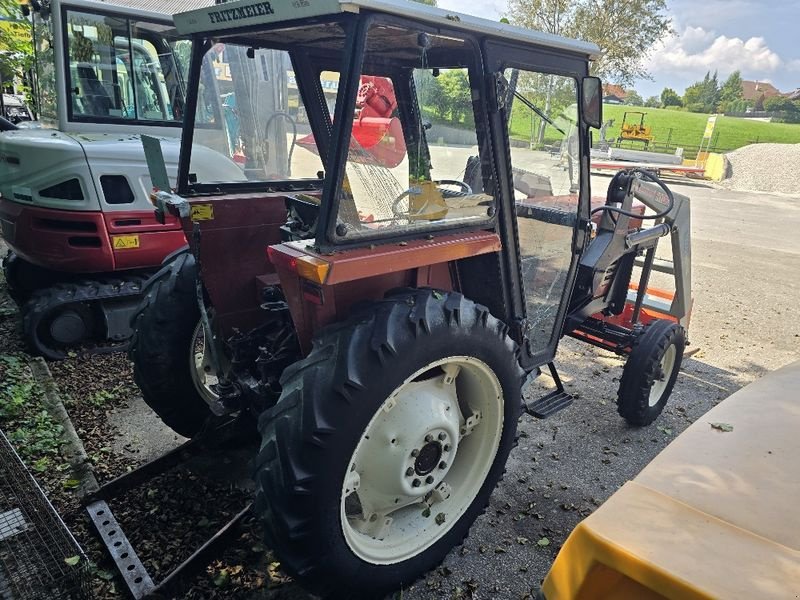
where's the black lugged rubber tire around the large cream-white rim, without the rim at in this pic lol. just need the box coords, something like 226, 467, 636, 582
254, 290, 523, 598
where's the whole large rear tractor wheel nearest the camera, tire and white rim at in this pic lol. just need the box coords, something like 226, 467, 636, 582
254, 290, 523, 598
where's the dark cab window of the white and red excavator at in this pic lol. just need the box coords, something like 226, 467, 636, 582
66, 10, 190, 125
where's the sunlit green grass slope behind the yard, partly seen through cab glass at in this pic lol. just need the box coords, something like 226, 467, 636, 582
511, 104, 800, 150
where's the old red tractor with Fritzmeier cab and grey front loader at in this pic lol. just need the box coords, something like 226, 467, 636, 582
129, 0, 689, 598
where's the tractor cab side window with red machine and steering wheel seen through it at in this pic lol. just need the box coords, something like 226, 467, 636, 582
336, 25, 494, 241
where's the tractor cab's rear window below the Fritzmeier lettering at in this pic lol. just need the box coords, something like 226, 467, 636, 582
189, 24, 344, 184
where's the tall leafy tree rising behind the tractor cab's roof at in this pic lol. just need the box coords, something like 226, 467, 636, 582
506, 0, 671, 85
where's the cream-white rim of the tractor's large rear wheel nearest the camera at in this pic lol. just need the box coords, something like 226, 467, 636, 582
340, 356, 503, 564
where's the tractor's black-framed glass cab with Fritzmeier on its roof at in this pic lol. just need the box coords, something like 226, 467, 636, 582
169, 2, 599, 364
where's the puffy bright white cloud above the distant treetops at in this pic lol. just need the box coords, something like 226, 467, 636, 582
648, 27, 795, 80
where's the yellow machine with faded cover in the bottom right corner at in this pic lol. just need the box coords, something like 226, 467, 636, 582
542, 361, 800, 600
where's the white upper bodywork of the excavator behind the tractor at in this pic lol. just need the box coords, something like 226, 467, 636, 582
0, 129, 244, 211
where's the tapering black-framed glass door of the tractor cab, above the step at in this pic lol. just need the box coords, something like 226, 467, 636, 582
484, 43, 589, 366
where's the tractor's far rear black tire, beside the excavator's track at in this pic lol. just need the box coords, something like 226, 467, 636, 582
128, 252, 212, 437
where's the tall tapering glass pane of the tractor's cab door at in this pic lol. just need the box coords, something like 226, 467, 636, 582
504, 69, 580, 354
